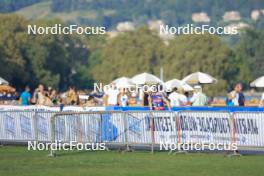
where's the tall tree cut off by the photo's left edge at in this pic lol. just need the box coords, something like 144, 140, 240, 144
0, 15, 30, 84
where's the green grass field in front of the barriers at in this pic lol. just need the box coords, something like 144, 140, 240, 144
0, 146, 264, 176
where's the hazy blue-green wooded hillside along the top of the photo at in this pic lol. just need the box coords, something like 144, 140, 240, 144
51, 0, 264, 27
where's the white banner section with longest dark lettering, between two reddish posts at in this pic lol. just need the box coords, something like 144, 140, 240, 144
177, 111, 232, 144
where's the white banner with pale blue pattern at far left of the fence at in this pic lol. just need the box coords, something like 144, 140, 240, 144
0, 111, 55, 141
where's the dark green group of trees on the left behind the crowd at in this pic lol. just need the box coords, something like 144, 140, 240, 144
0, 15, 94, 89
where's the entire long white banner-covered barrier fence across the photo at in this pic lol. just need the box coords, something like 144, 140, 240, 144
0, 110, 264, 153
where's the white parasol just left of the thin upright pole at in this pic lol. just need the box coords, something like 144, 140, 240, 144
132, 73, 163, 85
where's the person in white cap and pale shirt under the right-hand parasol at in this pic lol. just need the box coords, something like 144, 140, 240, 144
191, 85, 208, 106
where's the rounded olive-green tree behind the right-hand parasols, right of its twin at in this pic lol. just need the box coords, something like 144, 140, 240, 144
162, 34, 238, 95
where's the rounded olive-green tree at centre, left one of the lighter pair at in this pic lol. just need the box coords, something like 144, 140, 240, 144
92, 27, 164, 83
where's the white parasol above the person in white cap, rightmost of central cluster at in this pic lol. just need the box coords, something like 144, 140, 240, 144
182, 72, 217, 84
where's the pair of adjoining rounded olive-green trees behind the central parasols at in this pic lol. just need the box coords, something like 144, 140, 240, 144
93, 28, 239, 93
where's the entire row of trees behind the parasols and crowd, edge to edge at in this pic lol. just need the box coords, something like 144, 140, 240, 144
0, 15, 264, 95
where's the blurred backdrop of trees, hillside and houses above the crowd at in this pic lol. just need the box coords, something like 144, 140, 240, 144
0, 0, 264, 96
